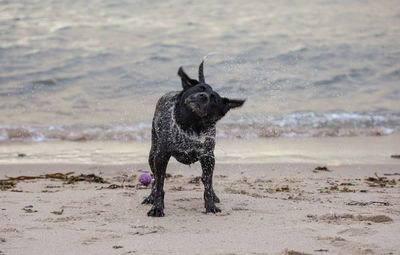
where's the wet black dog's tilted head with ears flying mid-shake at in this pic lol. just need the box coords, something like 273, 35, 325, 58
178, 61, 245, 122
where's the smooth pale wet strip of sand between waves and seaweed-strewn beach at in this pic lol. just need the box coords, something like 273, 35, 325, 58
0, 134, 400, 165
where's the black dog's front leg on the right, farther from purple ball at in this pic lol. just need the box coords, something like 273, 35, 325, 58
200, 154, 221, 213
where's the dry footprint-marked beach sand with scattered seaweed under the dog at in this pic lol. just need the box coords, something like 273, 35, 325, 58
0, 161, 400, 255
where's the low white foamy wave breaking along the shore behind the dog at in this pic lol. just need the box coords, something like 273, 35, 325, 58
0, 112, 400, 143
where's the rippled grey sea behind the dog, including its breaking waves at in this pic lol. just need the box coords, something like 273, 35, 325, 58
0, 0, 400, 143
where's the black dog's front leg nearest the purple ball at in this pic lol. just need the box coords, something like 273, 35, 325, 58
147, 155, 171, 217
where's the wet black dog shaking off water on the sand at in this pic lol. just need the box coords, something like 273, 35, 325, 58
142, 61, 244, 217
